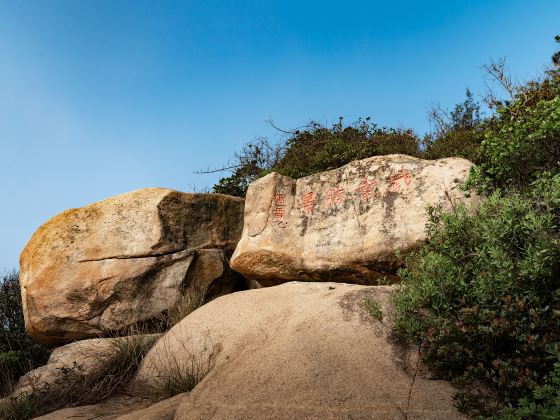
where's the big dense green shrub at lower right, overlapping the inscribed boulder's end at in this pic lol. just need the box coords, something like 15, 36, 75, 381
394, 174, 560, 414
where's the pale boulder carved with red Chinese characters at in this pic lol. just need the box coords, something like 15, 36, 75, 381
231, 155, 476, 286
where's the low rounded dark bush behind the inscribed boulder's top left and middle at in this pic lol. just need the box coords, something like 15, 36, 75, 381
213, 118, 420, 197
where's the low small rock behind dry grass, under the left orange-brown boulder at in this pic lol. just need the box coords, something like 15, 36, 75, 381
13, 334, 161, 395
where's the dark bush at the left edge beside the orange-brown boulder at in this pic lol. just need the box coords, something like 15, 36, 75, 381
0, 271, 50, 396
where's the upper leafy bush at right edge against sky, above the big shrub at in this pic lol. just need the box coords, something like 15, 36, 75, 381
468, 36, 560, 192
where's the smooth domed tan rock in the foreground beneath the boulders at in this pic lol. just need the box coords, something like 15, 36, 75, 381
132, 282, 463, 419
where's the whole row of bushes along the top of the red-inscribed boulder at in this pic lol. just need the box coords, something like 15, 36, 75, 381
210, 80, 484, 197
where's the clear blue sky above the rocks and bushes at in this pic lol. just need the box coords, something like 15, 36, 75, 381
0, 0, 560, 270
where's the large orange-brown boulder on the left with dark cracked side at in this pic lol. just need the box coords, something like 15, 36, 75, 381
20, 188, 244, 343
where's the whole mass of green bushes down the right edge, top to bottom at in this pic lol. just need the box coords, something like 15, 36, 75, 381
394, 37, 560, 419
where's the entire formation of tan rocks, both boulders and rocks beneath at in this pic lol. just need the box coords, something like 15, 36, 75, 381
16, 155, 478, 420
